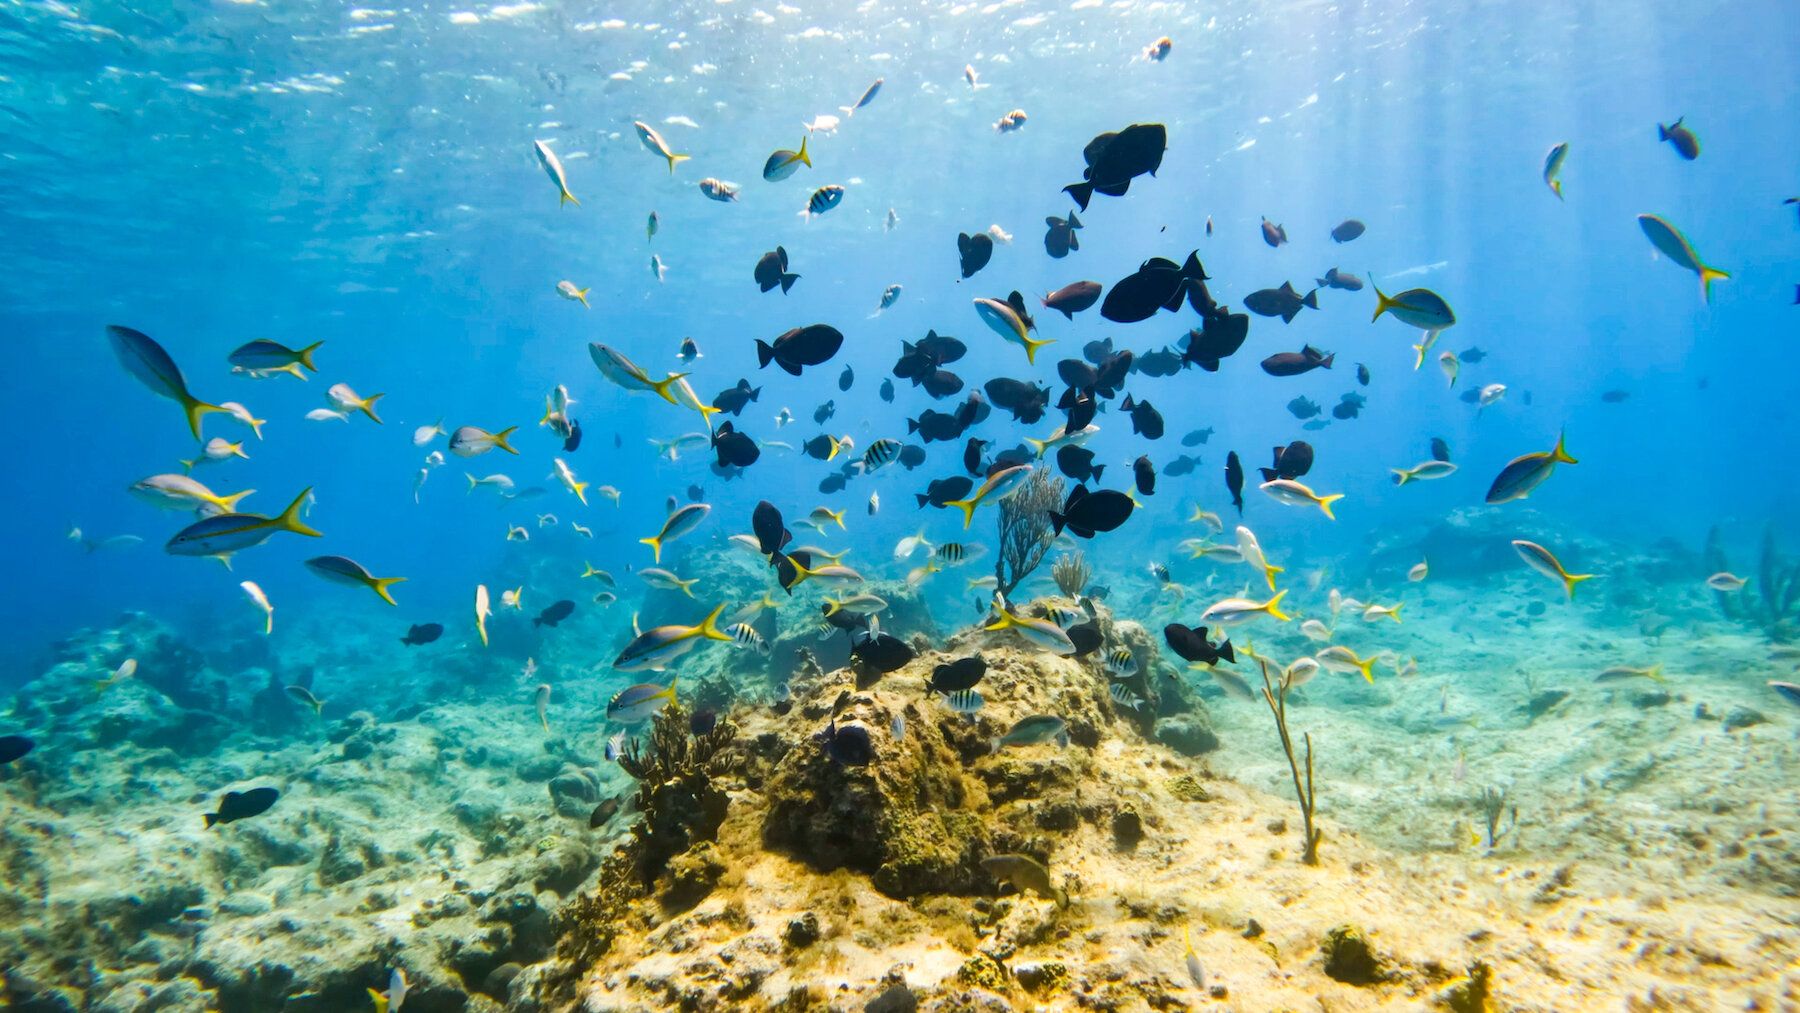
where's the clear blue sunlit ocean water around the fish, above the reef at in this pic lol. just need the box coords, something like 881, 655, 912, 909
0, 4, 1800, 690
